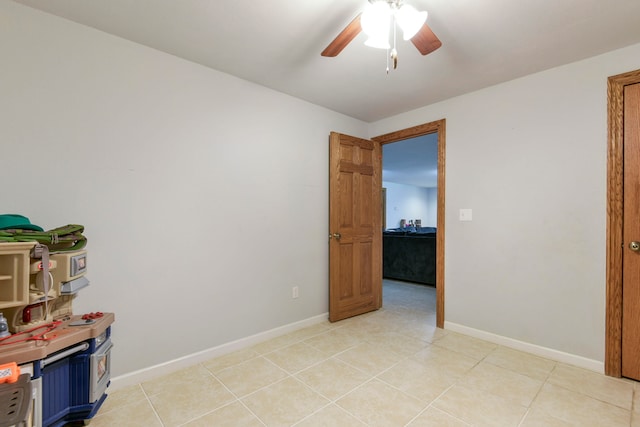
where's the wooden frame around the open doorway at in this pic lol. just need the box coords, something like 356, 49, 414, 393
371, 119, 446, 328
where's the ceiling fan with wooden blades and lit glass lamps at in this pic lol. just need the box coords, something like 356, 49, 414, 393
321, 0, 442, 63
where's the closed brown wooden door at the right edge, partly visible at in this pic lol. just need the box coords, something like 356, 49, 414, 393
622, 83, 640, 380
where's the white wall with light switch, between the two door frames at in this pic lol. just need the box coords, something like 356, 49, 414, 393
369, 41, 640, 361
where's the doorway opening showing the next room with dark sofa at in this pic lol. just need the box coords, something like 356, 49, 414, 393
382, 133, 438, 318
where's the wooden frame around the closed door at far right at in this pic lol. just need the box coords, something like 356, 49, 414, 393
604, 70, 640, 377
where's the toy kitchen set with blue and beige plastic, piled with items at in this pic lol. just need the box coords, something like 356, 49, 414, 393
0, 215, 114, 427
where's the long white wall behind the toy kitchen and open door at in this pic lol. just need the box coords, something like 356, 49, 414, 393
0, 2, 367, 375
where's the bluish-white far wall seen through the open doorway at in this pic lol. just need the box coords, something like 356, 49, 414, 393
382, 181, 438, 228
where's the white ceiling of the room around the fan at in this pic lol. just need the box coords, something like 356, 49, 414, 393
15, 0, 640, 122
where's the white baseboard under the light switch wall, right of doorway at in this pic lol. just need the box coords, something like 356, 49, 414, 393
444, 322, 604, 374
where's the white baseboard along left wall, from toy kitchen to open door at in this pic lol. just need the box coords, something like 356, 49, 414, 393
109, 313, 329, 391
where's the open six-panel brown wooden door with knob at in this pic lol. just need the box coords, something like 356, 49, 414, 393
329, 132, 382, 322
